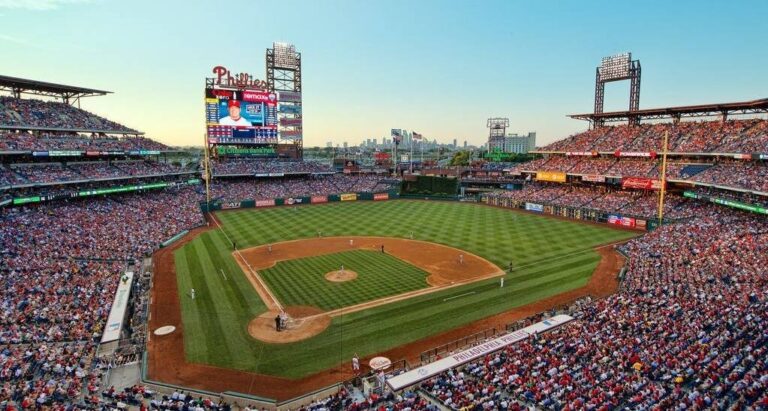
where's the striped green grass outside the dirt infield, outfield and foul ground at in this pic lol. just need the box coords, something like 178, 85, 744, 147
175, 200, 636, 378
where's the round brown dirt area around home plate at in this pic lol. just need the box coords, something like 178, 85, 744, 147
248, 306, 331, 344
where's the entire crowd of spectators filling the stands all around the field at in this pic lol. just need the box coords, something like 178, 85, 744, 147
0, 91, 768, 411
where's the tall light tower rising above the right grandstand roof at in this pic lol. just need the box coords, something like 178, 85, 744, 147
595, 53, 640, 126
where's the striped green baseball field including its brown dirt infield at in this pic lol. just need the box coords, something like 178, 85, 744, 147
158, 200, 636, 386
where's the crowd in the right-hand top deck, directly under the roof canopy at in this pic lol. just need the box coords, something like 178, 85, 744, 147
541, 119, 768, 153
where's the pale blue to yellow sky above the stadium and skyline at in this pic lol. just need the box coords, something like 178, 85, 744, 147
0, 0, 768, 146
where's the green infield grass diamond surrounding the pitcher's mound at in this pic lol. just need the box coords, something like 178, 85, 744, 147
259, 250, 429, 311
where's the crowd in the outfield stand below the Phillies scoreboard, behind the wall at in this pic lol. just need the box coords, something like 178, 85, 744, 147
211, 174, 392, 201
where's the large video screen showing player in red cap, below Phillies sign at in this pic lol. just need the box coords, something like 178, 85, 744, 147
205, 88, 277, 144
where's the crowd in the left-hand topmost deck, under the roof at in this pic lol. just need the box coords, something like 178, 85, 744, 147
0, 96, 136, 133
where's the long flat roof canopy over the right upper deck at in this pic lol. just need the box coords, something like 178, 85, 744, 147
568, 98, 768, 123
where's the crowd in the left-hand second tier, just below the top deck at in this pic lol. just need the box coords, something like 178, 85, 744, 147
0, 132, 169, 151
